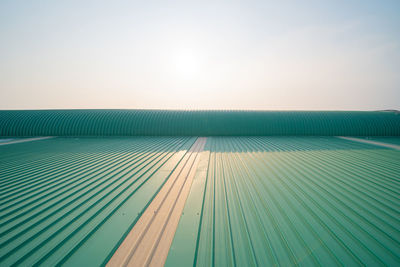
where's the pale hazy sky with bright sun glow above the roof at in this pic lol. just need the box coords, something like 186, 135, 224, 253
0, 0, 400, 110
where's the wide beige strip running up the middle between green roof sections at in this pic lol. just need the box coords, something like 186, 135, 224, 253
107, 137, 207, 266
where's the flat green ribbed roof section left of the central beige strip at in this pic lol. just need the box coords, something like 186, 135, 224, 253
0, 137, 195, 266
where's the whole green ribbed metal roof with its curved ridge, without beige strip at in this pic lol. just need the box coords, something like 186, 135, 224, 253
0, 110, 400, 266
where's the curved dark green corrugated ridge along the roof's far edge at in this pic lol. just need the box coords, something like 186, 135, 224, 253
0, 110, 400, 136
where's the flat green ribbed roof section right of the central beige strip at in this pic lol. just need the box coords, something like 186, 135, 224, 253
166, 137, 400, 266
